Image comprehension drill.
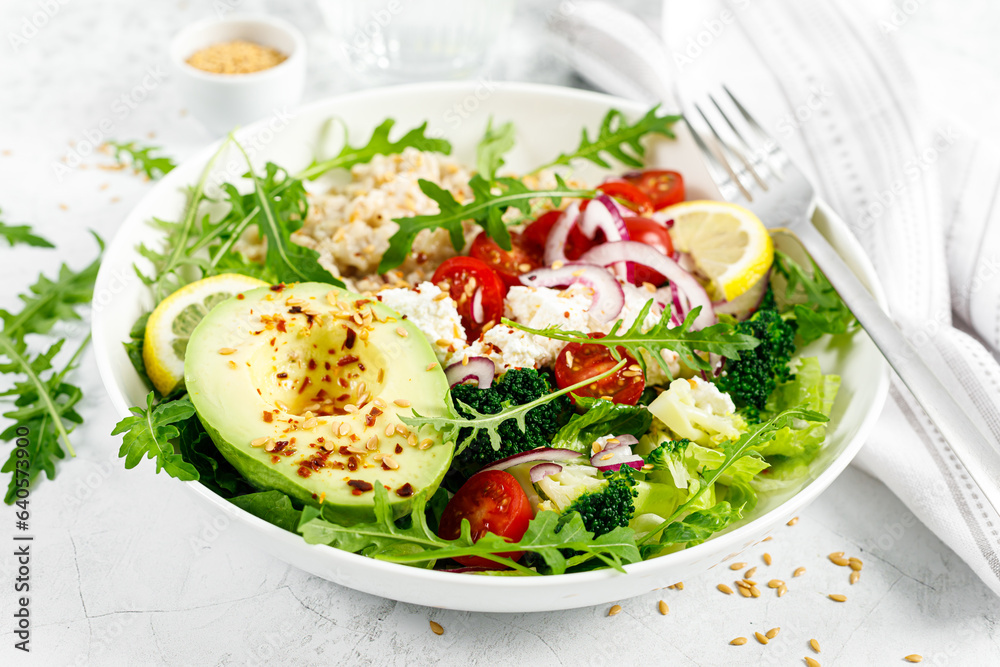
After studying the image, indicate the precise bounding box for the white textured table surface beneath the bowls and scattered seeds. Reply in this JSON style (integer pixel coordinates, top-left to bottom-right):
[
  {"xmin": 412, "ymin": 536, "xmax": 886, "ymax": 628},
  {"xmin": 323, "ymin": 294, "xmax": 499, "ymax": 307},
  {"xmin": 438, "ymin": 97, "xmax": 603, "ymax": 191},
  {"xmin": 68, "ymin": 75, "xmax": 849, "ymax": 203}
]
[{"xmin": 0, "ymin": 0, "xmax": 1000, "ymax": 665}]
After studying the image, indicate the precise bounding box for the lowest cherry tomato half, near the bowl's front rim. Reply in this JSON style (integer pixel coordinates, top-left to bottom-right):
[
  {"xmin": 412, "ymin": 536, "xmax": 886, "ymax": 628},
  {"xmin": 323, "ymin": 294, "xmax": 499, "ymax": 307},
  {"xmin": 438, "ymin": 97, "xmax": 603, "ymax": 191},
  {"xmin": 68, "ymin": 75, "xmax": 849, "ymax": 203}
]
[{"xmin": 438, "ymin": 470, "xmax": 531, "ymax": 568}]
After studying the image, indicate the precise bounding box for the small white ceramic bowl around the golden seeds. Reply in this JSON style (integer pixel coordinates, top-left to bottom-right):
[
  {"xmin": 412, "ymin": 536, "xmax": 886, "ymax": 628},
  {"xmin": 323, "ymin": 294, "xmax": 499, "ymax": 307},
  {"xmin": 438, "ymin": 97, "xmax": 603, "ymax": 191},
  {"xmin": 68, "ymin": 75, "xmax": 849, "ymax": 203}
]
[{"xmin": 170, "ymin": 16, "xmax": 306, "ymax": 135}]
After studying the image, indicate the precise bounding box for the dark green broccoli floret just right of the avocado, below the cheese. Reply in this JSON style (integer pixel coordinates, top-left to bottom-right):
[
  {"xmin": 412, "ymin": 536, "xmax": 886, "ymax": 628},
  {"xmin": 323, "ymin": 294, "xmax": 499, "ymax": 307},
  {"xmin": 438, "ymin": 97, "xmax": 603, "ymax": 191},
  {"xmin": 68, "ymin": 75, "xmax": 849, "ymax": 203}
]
[{"xmin": 451, "ymin": 368, "xmax": 571, "ymax": 476}]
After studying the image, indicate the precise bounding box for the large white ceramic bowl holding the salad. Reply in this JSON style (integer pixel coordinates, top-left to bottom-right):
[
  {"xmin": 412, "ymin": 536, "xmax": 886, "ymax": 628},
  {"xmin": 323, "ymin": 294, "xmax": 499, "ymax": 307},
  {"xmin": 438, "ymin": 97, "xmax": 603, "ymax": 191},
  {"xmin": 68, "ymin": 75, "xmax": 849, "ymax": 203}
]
[{"xmin": 93, "ymin": 83, "xmax": 888, "ymax": 612}]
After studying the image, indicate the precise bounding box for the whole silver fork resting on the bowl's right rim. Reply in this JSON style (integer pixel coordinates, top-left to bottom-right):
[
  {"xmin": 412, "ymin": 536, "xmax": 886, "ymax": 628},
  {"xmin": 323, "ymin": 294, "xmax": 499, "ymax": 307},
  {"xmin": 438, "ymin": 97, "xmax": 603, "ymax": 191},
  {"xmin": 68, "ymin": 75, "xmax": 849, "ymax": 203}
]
[{"xmin": 684, "ymin": 86, "xmax": 1000, "ymax": 512}]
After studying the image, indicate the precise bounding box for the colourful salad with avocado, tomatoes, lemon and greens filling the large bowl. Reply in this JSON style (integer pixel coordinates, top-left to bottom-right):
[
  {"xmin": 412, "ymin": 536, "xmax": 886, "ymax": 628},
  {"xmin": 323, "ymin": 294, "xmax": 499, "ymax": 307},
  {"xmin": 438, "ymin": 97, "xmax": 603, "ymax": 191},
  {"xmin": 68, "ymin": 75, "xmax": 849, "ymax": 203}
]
[{"xmin": 114, "ymin": 92, "xmax": 854, "ymax": 577}]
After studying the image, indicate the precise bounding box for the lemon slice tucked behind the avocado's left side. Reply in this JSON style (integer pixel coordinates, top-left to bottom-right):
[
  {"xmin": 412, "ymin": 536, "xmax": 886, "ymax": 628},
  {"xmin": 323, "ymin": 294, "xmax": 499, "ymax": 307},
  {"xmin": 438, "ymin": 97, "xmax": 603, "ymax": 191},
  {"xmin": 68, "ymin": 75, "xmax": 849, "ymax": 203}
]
[{"xmin": 142, "ymin": 273, "xmax": 267, "ymax": 394}]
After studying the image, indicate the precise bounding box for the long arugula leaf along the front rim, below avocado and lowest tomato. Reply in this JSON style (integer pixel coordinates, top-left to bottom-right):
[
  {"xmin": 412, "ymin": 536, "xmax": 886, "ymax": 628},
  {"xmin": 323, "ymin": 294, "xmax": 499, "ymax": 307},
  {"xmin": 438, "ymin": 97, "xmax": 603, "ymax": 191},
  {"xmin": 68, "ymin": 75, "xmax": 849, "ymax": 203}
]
[{"xmin": 299, "ymin": 485, "xmax": 639, "ymax": 575}]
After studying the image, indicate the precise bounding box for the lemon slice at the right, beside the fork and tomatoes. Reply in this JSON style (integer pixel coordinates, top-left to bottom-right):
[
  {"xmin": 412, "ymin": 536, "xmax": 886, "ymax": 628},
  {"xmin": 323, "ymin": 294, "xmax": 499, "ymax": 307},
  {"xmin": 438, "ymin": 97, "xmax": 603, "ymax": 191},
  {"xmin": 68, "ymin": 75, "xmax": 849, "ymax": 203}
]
[{"xmin": 661, "ymin": 201, "xmax": 774, "ymax": 301}]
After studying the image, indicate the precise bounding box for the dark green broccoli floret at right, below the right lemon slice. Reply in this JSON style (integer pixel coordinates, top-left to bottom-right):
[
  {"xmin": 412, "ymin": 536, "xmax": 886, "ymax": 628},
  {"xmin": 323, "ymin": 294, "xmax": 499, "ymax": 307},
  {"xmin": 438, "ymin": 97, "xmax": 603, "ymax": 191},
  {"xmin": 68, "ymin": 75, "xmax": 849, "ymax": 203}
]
[{"xmin": 717, "ymin": 288, "xmax": 796, "ymax": 420}]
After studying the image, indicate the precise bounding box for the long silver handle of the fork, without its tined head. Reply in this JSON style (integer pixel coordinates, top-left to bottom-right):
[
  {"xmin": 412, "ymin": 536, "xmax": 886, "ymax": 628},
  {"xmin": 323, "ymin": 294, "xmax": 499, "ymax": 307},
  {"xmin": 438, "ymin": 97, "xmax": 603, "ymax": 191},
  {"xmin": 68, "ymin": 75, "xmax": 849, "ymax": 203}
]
[{"xmin": 792, "ymin": 220, "xmax": 1000, "ymax": 513}]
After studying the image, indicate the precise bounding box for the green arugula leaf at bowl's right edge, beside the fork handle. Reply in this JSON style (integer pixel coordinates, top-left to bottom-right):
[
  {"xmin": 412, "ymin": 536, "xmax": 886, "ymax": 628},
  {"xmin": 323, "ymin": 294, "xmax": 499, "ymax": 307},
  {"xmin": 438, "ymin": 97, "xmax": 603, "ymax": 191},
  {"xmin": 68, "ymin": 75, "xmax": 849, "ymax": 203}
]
[{"xmin": 774, "ymin": 250, "xmax": 857, "ymax": 343}]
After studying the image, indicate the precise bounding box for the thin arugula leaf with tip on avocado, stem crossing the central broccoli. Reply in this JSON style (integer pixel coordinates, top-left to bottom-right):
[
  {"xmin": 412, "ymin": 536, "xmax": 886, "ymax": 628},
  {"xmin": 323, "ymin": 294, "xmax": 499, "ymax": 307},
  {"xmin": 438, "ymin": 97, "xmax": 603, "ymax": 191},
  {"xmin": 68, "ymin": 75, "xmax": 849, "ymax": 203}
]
[{"xmin": 399, "ymin": 359, "xmax": 628, "ymax": 456}]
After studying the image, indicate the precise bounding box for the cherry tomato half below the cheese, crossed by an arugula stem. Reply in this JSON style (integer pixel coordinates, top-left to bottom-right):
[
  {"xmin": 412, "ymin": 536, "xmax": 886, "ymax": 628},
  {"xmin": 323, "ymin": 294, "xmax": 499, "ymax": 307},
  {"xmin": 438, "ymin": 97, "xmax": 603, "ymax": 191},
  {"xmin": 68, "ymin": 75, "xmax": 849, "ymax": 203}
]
[{"xmin": 555, "ymin": 333, "xmax": 646, "ymax": 405}]
